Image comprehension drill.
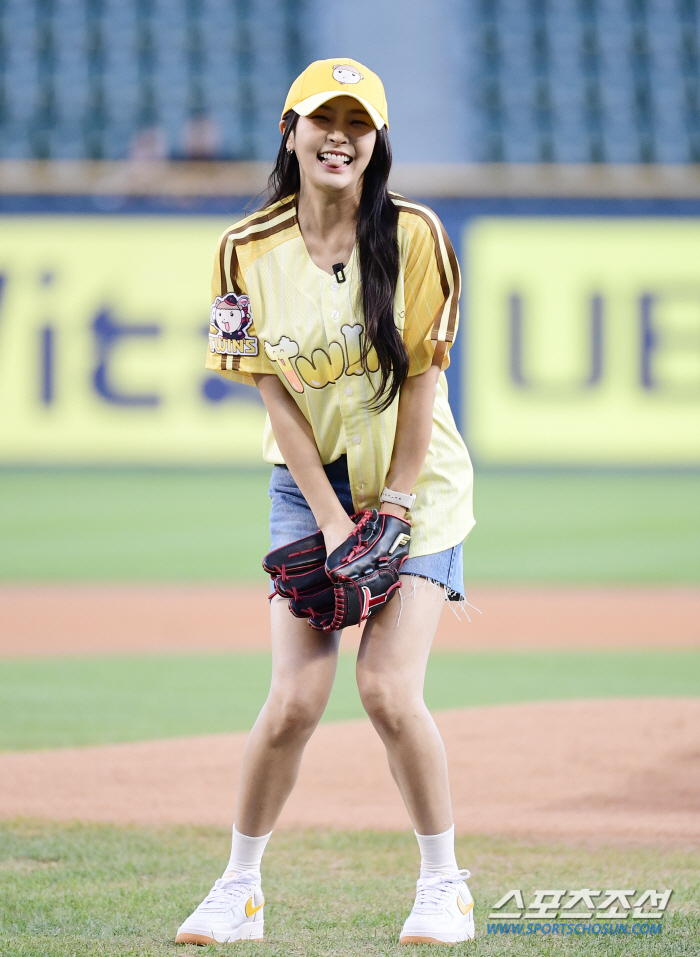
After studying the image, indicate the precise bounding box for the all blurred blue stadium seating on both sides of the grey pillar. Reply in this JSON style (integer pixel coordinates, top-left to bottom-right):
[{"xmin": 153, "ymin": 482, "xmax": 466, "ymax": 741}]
[{"xmin": 0, "ymin": 0, "xmax": 700, "ymax": 163}]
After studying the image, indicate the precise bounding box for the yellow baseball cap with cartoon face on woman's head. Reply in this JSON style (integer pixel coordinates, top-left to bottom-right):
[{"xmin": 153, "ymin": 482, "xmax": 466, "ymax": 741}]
[{"xmin": 282, "ymin": 57, "xmax": 389, "ymax": 130}]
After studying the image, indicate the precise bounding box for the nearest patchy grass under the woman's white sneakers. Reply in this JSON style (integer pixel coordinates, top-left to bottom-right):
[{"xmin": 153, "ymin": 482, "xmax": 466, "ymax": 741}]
[{"xmin": 0, "ymin": 821, "xmax": 700, "ymax": 957}]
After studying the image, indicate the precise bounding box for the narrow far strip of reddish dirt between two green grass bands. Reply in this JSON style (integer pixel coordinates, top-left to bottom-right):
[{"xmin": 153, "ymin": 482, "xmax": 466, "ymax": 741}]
[{"xmin": 0, "ymin": 585, "xmax": 700, "ymax": 655}]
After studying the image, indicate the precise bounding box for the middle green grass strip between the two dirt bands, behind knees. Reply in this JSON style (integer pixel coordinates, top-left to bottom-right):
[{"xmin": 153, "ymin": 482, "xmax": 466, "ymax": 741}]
[{"xmin": 0, "ymin": 651, "xmax": 700, "ymax": 750}]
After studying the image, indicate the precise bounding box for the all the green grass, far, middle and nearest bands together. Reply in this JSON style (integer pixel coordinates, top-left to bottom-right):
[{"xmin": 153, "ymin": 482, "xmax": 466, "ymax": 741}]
[{"xmin": 0, "ymin": 470, "xmax": 700, "ymax": 957}]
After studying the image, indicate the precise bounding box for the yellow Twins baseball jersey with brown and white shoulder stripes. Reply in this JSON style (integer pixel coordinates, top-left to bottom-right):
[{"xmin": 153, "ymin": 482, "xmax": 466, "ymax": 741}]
[{"xmin": 207, "ymin": 194, "xmax": 474, "ymax": 557}]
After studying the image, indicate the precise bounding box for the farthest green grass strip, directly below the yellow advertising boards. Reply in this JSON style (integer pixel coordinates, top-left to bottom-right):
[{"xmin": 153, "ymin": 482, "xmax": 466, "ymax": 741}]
[{"xmin": 0, "ymin": 470, "xmax": 700, "ymax": 584}]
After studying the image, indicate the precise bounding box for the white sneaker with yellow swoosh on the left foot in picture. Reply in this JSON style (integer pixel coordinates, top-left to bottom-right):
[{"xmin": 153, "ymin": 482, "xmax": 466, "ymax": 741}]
[{"xmin": 175, "ymin": 871, "xmax": 265, "ymax": 944}]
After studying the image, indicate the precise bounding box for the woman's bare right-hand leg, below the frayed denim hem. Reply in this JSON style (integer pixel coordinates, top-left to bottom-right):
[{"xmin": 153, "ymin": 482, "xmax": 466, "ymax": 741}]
[{"xmin": 357, "ymin": 575, "xmax": 452, "ymax": 834}]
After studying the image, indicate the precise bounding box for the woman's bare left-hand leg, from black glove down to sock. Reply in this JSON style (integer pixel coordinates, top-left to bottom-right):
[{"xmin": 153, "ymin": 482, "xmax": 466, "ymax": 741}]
[{"xmin": 236, "ymin": 598, "xmax": 341, "ymax": 837}]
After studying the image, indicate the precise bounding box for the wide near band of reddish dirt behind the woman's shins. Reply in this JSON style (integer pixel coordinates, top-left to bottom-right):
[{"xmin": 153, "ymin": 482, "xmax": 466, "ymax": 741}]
[{"xmin": 0, "ymin": 699, "xmax": 700, "ymax": 846}]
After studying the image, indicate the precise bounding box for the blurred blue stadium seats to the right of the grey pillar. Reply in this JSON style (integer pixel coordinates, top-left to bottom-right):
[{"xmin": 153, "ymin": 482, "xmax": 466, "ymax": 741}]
[{"xmin": 474, "ymin": 0, "xmax": 700, "ymax": 163}]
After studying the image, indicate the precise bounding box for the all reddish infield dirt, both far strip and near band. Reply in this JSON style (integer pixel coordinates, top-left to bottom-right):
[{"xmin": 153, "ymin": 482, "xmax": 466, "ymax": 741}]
[{"xmin": 0, "ymin": 586, "xmax": 700, "ymax": 846}]
